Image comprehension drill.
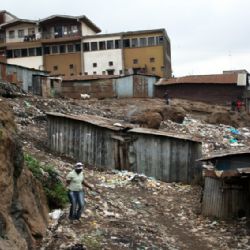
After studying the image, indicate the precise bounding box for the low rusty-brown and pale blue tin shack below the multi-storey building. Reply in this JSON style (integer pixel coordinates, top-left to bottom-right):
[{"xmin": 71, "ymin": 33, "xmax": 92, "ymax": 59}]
[{"xmin": 61, "ymin": 74, "xmax": 158, "ymax": 99}]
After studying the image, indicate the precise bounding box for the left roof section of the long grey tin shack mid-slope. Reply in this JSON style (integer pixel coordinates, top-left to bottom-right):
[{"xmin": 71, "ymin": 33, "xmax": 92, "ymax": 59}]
[{"xmin": 46, "ymin": 112, "xmax": 134, "ymax": 131}]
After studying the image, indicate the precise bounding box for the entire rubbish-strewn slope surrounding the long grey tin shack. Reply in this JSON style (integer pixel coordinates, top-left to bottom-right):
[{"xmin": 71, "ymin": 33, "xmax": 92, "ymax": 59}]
[{"xmin": 1, "ymin": 93, "xmax": 250, "ymax": 250}]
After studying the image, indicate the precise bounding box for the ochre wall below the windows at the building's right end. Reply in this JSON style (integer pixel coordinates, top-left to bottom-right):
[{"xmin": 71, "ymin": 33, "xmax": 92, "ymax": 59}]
[{"xmin": 124, "ymin": 45, "xmax": 164, "ymax": 77}]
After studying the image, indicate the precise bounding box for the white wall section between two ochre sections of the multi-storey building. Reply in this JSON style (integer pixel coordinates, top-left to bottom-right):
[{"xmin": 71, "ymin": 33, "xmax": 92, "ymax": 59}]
[{"xmin": 83, "ymin": 36, "xmax": 124, "ymax": 75}]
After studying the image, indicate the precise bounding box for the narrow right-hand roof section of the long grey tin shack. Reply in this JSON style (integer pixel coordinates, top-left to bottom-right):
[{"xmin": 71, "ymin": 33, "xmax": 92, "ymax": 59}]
[{"xmin": 128, "ymin": 128, "xmax": 201, "ymax": 143}]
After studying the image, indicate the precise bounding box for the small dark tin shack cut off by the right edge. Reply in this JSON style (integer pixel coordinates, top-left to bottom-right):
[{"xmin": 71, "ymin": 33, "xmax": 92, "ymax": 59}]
[{"xmin": 200, "ymin": 152, "xmax": 250, "ymax": 219}]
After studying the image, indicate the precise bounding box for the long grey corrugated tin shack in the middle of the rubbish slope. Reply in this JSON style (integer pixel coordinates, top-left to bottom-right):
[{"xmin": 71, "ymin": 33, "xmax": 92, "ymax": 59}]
[{"xmin": 47, "ymin": 113, "xmax": 201, "ymax": 183}]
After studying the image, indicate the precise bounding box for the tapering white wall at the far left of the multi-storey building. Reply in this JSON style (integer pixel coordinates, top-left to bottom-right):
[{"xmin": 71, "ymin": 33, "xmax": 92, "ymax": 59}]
[{"xmin": 7, "ymin": 56, "xmax": 43, "ymax": 70}]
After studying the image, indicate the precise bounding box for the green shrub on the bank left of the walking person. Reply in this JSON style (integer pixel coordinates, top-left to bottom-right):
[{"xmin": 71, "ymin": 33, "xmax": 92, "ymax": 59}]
[{"xmin": 24, "ymin": 154, "xmax": 68, "ymax": 209}]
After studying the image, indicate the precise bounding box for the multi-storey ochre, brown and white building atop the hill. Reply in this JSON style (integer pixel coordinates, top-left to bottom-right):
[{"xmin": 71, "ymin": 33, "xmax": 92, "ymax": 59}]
[{"xmin": 0, "ymin": 12, "xmax": 171, "ymax": 77}]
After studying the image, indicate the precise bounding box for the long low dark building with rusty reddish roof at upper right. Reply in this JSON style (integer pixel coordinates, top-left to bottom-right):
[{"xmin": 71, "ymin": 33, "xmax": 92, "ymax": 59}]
[{"xmin": 155, "ymin": 71, "xmax": 246, "ymax": 105}]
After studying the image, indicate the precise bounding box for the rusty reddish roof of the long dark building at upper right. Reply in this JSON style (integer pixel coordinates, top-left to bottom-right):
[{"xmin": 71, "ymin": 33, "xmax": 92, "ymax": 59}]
[{"xmin": 155, "ymin": 74, "xmax": 238, "ymax": 86}]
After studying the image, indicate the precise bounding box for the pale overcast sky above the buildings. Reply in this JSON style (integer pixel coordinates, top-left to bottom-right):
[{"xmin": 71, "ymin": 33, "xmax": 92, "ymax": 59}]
[{"xmin": 0, "ymin": 0, "xmax": 250, "ymax": 76}]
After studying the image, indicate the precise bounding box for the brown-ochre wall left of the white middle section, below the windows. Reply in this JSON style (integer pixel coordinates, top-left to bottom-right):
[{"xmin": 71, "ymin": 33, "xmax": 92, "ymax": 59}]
[{"xmin": 44, "ymin": 53, "xmax": 82, "ymax": 76}]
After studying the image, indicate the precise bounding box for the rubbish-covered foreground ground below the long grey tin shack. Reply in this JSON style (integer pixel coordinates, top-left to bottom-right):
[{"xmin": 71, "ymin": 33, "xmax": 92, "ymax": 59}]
[{"xmin": 40, "ymin": 169, "xmax": 250, "ymax": 250}]
